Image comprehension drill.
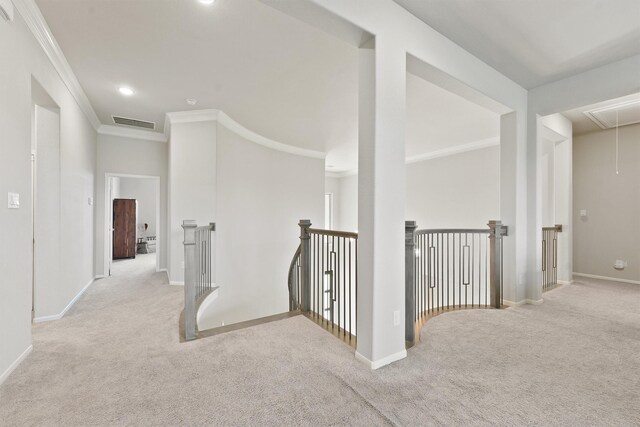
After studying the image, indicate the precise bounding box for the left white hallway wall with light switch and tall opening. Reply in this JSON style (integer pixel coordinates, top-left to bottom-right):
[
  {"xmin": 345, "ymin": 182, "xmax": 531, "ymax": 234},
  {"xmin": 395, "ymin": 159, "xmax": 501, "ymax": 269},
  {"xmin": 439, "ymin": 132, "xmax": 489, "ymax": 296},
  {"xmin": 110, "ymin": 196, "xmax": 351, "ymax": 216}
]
[{"xmin": 0, "ymin": 13, "xmax": 96, "ymax": 381}]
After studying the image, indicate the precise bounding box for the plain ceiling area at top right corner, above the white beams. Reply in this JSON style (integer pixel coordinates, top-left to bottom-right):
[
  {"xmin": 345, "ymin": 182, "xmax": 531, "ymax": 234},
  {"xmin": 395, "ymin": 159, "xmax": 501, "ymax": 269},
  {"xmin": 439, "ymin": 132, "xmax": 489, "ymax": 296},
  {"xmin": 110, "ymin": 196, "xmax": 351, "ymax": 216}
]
[{"xmin": 395, "ymin": 0, "xmax": 640, "ymax": 89}]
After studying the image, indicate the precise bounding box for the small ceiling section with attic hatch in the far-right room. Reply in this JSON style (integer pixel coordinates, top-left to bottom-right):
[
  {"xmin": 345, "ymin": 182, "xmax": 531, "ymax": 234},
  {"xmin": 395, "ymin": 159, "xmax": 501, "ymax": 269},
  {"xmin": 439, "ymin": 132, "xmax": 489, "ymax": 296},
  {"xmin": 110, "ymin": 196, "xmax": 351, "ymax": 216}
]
[{"xmin": 562, "ymin": 93, "xmax": 640, "ymax": 135}]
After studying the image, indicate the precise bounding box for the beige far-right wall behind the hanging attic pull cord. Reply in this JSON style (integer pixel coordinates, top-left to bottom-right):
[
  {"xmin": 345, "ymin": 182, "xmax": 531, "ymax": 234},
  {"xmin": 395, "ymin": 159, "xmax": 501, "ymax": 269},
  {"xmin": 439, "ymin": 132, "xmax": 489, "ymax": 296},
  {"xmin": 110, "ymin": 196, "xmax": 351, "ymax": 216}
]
[{"xmin": 573, "ymin": 125, "xmax": 640, "ymax": 282}]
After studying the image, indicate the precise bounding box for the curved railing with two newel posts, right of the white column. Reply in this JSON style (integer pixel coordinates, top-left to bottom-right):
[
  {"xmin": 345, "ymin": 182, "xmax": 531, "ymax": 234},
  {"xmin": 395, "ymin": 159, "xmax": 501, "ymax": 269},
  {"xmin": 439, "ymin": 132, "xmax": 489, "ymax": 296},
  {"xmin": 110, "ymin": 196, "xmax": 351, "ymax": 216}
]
[{"xmin": 405, "ymin": 221, "xmax": 508, "ymax": 347}]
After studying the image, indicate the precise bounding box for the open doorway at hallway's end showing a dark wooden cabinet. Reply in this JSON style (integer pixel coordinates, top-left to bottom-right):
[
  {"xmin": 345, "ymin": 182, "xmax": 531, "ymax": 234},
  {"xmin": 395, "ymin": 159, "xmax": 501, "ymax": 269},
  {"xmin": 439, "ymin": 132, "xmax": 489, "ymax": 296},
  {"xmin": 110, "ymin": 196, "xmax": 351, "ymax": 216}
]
[{"xmin": 104, "ymin": 173, "xmax": 161, "ymax": 276}]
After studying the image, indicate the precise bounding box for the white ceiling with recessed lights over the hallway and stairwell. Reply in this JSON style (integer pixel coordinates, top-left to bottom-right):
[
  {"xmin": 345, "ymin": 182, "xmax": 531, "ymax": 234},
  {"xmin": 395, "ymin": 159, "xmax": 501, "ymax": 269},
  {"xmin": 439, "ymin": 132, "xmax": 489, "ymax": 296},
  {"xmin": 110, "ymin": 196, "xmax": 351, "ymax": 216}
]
[{"xmin": 36, "ymin": 0, "xmax": 499, "ymax": 171}]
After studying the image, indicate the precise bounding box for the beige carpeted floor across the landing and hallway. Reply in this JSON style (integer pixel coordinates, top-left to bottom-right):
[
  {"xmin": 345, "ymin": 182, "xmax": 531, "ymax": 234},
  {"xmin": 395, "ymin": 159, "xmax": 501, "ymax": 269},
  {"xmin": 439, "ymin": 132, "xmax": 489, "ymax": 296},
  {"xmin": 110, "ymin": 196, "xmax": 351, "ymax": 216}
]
[{"xmin": 0, "ymin": 264, "xmax": 640, "ymax": 426}]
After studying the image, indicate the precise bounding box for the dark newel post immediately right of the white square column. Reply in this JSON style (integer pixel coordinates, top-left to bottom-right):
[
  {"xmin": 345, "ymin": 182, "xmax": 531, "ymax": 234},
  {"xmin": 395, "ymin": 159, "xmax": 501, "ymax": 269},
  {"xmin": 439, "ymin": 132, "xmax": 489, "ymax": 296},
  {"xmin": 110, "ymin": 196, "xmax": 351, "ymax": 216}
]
[{"xmin": 404, "ymin": 221, "xmax": 418, "ymax": 347}]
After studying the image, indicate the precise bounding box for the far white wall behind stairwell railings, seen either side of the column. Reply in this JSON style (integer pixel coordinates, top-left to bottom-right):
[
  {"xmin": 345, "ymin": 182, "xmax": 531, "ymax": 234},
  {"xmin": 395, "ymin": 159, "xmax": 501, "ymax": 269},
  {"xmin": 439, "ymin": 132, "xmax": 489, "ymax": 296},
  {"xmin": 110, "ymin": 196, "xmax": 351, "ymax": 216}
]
[{"xmin": 336, "ymin": 146, "xmax": 500, "ymax": 231}]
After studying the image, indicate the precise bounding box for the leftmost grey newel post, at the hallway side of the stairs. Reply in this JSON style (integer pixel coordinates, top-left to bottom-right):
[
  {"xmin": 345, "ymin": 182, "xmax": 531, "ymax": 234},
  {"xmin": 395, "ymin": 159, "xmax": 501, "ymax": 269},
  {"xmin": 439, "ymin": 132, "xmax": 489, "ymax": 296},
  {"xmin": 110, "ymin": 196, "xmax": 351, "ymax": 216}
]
[{"xmin": 182, "ymin": 220, "xmax": 197, "ymax": 341}]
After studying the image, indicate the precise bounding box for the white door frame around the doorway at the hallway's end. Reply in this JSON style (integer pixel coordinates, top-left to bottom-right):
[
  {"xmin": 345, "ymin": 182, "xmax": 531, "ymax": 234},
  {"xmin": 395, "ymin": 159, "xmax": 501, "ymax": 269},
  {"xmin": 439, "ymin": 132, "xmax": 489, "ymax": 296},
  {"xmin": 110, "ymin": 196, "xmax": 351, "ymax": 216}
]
[{"xmin": 103, "ymin": 172, "xmax": 163, "ymax": 277}]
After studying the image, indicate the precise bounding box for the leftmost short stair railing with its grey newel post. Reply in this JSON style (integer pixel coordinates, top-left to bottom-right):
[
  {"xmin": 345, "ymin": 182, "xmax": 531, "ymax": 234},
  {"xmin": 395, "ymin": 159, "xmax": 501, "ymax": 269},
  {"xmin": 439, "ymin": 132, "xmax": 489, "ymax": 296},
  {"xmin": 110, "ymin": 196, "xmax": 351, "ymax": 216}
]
[{"xmin": 182, "ymin": 220, "xmax": 216, "ymax": 341}]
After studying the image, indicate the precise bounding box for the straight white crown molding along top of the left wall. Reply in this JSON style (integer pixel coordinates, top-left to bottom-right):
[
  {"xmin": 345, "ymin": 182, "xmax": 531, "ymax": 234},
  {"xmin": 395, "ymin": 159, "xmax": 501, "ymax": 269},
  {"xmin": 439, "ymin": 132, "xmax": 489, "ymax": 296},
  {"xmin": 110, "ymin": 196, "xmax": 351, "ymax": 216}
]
[{"xmin": 13, "ymin": 0, "xmax": 101, "ymax": 131}]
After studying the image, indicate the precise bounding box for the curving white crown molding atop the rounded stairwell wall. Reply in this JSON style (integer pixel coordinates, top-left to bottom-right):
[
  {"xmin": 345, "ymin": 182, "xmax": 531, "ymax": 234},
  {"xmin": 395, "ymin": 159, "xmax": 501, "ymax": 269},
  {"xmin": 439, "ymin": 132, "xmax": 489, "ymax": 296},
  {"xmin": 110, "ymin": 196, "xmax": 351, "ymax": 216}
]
[{"xmin": 164, "ymin": 109, "xmax": 326, "ymax": 160}]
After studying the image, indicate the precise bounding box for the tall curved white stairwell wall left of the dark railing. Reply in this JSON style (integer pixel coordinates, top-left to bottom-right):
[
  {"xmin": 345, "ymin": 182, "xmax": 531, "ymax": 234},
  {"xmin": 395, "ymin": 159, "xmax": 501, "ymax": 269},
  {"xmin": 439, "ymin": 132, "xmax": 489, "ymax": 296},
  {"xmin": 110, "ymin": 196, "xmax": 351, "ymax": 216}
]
[{"xmin": 200, "ymin": 125, "xmax": 324, "ymax": 328}]
